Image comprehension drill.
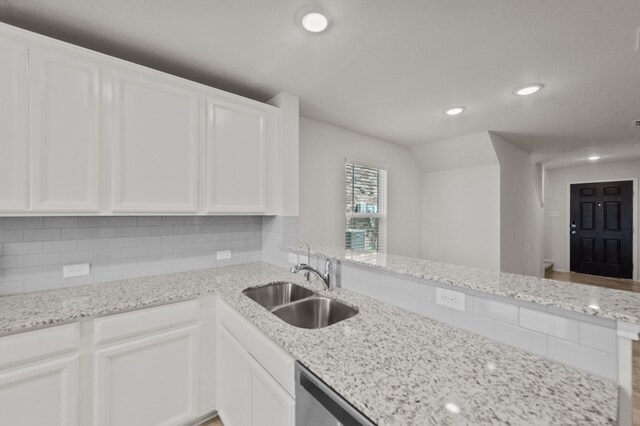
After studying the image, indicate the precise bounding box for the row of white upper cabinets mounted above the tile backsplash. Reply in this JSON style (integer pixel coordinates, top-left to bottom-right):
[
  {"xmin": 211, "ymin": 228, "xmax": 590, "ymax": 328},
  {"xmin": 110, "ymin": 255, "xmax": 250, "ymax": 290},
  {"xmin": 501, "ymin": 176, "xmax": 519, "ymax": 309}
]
[{"xmin": 0, "ymin": 23, "xmax": 284, "ymax": 216}]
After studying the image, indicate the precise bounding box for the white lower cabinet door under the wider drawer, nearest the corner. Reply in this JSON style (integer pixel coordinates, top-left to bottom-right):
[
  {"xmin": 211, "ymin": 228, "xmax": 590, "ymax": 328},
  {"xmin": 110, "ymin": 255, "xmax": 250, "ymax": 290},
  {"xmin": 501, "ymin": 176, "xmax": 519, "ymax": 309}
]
[{"xmin": 95, "ymin": 326, "xmax": 199, "ymax": 426}]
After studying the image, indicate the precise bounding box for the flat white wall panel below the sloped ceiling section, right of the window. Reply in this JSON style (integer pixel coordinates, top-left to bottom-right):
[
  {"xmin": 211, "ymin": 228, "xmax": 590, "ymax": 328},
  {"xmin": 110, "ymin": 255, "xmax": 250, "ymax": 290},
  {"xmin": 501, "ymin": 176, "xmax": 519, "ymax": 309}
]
[{"xmin": 422, "ymin": 165, "xmax": 500, "ymax": 270}]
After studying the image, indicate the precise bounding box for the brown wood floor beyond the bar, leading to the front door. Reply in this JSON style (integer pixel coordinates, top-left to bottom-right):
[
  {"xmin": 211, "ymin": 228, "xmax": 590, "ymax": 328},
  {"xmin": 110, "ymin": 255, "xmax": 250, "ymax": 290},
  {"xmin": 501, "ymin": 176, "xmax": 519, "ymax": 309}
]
[{"xmin": 545, "ymin": 270, "xmax": 640, "ymax": 425}]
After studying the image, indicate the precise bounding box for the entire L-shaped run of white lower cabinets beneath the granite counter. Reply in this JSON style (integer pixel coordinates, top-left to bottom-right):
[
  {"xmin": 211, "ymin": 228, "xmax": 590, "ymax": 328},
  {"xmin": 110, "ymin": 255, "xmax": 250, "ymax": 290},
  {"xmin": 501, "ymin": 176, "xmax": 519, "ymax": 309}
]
[{"xmin": 0, "ymin": 296, "xmax": 295, "ymax": 426}]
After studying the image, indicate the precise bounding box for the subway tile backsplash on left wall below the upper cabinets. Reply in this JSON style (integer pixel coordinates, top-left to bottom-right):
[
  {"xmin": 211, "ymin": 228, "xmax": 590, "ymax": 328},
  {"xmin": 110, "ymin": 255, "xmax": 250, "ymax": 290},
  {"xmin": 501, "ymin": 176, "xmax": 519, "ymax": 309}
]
[{"xmin": 0, "ymin": 216, "xmax": 262, "ymax": 294}]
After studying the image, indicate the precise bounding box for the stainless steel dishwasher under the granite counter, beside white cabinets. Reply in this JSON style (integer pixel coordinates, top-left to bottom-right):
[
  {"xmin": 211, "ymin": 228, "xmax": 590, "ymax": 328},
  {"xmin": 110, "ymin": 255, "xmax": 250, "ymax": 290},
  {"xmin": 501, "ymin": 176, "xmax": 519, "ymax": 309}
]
[{"xmin": 296, "ymin": 362, "xmax": 375, "ymax": 426}]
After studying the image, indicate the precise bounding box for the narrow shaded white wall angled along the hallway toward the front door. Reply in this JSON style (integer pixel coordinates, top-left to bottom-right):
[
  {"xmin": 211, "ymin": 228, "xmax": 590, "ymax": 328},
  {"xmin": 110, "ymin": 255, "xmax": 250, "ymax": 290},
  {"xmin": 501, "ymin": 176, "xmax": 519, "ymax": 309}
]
[{"xmin": 490, "ymin": 133, "xmax": 544, "ymax": 276}]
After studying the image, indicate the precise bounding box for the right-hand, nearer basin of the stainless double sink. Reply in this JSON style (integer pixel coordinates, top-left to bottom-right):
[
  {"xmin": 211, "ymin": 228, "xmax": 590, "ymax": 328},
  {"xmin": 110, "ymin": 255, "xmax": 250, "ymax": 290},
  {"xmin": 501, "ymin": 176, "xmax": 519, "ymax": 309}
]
[{"xmin": 273, "ymin": 297, "xmax": 358, "ymax": 328}]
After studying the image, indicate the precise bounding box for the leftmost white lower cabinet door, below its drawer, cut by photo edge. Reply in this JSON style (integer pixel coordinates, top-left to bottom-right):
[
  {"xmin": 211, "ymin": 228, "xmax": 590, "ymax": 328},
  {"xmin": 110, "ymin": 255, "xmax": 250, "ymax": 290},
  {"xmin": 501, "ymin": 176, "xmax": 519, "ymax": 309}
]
[{"xmin": 0, "ymin": 355, "xmax": 80, "ymax": 426}]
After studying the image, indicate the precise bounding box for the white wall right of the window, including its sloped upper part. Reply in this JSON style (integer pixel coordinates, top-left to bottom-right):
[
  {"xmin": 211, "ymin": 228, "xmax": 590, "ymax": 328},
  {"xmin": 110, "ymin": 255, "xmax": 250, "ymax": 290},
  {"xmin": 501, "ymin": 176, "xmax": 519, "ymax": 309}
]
[{"xmin": 411, "ymin": 132, "xmax": 500, "ymax": 270}]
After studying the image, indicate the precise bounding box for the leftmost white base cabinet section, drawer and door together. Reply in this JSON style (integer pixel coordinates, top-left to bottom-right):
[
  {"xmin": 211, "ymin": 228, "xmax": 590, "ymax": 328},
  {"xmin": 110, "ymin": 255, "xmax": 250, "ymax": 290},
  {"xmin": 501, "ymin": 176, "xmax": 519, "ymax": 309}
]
[{"xmin": 0, "ymin": 324, "xmax": 80, "ymax": 426}]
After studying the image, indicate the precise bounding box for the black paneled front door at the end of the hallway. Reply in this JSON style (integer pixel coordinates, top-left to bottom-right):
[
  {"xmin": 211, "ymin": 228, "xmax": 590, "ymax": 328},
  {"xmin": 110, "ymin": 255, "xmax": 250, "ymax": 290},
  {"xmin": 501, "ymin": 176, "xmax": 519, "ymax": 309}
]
[{"xmin": 569, "ymin": 181, "xmax": 633, "ymax": 278}]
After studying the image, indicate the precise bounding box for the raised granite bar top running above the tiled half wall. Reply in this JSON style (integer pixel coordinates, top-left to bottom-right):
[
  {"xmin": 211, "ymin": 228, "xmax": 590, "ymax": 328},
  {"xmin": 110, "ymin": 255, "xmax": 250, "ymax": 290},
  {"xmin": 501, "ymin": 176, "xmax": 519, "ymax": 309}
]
[{"xmin": 284, "ymin": 246, "xmax": 640, "ymax": 325}]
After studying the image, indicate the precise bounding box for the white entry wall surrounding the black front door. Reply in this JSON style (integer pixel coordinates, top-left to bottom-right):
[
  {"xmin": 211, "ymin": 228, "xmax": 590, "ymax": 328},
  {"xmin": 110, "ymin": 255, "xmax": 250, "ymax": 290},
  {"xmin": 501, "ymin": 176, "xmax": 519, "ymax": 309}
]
[{"xmin": 544, "ymin": 161, "xmax": 640, "ymax": 271}]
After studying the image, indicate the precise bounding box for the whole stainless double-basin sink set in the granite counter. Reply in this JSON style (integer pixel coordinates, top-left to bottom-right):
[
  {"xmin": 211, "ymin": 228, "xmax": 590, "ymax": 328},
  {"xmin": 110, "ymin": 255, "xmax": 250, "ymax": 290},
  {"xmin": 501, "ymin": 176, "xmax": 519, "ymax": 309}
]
[{"xmin": 243, "ymin": 282, "xmax": 358, "ymax": 329}]
